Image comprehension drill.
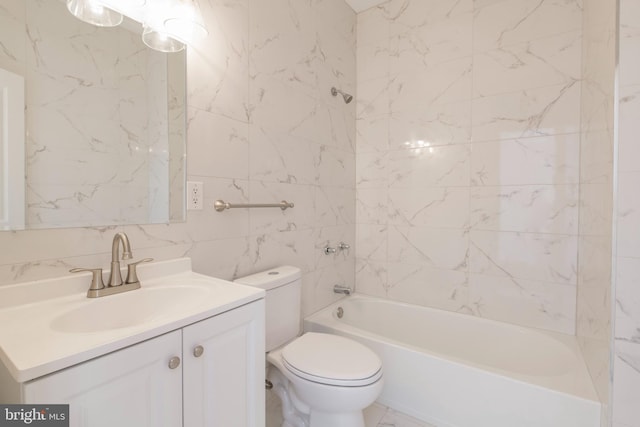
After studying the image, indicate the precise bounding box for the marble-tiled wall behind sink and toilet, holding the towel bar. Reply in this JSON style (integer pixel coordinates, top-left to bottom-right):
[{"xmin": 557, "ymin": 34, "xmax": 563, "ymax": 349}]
[{"xmin": 0, "ymin": 0, "xmax": 356, "ymax": 320}]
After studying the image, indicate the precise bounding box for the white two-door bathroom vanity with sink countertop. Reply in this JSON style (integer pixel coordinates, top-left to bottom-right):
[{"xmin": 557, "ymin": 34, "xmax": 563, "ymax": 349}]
[{"xmin": 0, "ymin": 259, "xmax": 265, "ymax": 427}]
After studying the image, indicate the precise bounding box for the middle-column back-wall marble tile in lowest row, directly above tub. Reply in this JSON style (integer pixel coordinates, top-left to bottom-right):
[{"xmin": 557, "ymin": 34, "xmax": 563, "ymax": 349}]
[{"xmin": 387, "ymin": 262, "xmax": 469, "ymax": 312}]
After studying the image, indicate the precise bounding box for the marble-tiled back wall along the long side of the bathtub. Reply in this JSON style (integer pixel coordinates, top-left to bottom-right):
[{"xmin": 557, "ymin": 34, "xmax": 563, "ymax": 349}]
[{"xmin": 356, "ymin": 0, "xmax": 582, "ymax": 334}]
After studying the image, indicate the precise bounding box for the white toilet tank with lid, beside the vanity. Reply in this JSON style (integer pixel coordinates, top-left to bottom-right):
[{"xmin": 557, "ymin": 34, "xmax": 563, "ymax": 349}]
[{"xmin": 235, "ymin": 265, "xmax": 302, "ymax": 351}]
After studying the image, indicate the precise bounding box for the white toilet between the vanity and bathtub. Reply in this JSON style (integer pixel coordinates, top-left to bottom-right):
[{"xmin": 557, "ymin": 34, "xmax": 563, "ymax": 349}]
[{"xmin": 236, "ymin": 266, "xmax": 383, "ymax": 427}]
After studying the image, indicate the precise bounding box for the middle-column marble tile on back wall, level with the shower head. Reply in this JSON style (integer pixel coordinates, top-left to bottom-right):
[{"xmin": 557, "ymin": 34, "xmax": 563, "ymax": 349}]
[{"xmin": 389, "ymin": 56, "xmax": 472, "ymax": 115}]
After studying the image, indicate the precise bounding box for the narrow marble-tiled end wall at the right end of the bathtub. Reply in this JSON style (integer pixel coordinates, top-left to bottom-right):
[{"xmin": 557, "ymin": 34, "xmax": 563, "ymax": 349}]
[{"xmin": 576, "ymin": 0, "xmax": 617, "ymax": 426}]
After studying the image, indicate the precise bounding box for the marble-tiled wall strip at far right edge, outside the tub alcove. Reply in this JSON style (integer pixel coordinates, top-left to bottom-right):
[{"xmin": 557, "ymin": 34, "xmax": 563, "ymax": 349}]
[{"xmin": 612, "ymin": 0, "xmax": 640, "ymax": 427}]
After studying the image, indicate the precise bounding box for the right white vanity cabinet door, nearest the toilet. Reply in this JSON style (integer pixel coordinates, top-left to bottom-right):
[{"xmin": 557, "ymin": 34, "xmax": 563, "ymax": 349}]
[{"xmin": 183, "ymin": 300, "xmax": 265, "ymax": 427}]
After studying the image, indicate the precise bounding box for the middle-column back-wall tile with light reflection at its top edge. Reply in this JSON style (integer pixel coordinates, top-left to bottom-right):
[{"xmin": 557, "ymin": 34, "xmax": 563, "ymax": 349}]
[{"xmin": 388, "ymin": 144, "xmax": 471, "ymax": 188}]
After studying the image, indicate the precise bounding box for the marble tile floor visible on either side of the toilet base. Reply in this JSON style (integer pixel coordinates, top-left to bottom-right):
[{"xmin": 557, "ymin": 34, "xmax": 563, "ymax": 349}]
[{"xmin": 266, "ymin": 391, "xmax": 436, "ymax": 427}]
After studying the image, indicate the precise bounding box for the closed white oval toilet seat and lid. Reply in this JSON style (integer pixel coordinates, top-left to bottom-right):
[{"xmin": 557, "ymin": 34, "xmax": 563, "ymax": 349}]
[{"xmin": 282, "ymin": 332, "xmax": 382, "ymax": 387}]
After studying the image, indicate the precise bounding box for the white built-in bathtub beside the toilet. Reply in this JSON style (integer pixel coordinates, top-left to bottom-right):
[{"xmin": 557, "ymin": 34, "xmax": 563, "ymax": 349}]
[{"xmin": 304, "ymin": 295, "xmax": 600, "ymax": 427}]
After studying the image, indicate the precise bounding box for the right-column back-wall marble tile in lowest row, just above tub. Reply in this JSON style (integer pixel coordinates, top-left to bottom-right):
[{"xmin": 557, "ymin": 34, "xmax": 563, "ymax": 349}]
[{"xmin": 469, "ymin": 274, "xmax": 576, "ymax": 335}]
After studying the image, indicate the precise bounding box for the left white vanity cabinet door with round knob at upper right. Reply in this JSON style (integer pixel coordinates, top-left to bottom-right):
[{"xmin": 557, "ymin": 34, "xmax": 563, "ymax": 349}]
[{"xmin": 23, "ymin": 331, "xmax": 182, "ymax": 427}]
